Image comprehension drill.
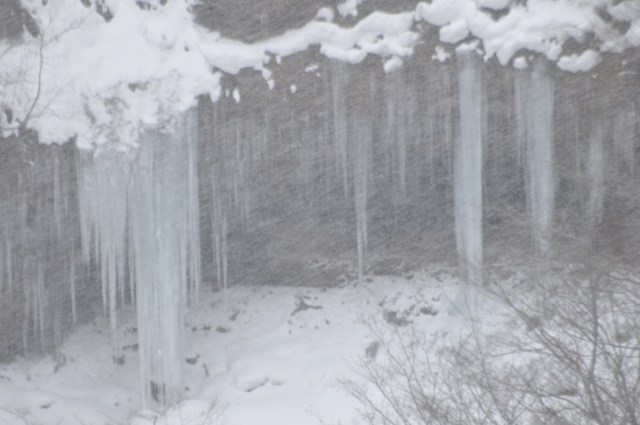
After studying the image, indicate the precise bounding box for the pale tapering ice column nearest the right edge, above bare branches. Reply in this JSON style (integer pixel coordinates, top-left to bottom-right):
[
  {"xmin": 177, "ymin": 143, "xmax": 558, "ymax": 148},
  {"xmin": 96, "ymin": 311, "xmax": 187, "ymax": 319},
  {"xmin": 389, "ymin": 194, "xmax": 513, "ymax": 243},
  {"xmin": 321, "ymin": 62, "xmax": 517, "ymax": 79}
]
[{"xmin": 525, "ymin": 58, "xmax": 555, "ymax": 254}]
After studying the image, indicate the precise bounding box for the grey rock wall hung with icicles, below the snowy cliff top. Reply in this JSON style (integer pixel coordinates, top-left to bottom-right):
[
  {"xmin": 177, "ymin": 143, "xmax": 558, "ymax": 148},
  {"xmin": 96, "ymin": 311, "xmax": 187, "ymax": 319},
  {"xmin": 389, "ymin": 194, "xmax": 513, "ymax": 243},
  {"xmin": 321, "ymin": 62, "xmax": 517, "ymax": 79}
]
[{"xmin": 0, "ymin": 40, "xmax": 640, "ymax": 414}]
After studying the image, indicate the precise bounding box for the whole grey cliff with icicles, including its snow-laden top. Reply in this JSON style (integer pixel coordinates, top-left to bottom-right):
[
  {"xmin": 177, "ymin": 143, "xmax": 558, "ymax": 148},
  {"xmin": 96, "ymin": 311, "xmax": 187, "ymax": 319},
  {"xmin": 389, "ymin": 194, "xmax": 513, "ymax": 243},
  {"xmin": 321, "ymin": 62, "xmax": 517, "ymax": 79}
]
[{"xmin": 0, "ymin": 0, "xmax": 640, "ymax": 410}]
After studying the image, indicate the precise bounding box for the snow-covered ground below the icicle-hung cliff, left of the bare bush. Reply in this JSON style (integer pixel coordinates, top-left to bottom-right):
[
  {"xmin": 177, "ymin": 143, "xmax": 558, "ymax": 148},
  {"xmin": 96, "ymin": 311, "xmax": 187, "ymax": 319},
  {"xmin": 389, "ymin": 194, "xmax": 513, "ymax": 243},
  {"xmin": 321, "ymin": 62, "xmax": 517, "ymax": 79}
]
[{"xmin": 0, "ymin": 267, "xmax": 465, "ymax": 425}]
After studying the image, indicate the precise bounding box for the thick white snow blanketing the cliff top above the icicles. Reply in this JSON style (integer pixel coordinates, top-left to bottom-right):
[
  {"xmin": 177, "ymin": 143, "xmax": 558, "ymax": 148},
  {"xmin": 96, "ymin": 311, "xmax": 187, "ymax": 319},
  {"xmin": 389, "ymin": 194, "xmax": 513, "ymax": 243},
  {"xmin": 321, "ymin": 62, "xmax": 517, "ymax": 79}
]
[{"xmin": 0, "ymin": 0, "xmax": 640, "ymax": 150}]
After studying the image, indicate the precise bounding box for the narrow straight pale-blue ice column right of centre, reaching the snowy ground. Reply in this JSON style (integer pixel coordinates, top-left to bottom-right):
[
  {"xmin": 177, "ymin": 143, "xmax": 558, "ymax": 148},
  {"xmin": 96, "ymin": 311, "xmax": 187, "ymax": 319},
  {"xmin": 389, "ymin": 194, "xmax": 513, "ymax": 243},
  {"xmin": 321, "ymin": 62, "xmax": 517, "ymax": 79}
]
[{"xmin": 454, "ymin": 50, "xmax": 482, "ymax": 283}]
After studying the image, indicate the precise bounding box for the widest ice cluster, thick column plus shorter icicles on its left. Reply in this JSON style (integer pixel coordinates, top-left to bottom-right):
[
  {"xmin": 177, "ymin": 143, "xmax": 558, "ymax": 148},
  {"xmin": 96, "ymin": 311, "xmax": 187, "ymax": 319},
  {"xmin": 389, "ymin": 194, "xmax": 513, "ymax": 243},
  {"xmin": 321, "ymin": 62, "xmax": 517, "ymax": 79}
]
[{"xmin": 78, "ymin": 107, "xmax": 200, "ymax": 406}]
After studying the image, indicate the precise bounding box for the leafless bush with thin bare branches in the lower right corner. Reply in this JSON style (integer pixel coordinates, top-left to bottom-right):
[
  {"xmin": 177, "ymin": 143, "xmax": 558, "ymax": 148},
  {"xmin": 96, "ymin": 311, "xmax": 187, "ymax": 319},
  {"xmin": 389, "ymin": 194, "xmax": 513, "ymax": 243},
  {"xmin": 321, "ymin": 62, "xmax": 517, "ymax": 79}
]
[{"xmin": 345, "ymin": 264, "xmax": 640, "ymax": 425}]
